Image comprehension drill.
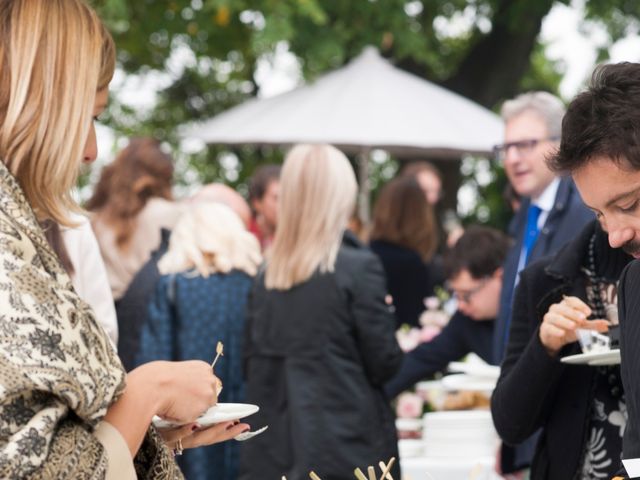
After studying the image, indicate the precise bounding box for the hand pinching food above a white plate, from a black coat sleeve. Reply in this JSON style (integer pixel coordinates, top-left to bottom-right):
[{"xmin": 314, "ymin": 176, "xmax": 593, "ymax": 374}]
[{"xmin": 540, "ymin": 297, "xmax": 609, "ymax": 356}]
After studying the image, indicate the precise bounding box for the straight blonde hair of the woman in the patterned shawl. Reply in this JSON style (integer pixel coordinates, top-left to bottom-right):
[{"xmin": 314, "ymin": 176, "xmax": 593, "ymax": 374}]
[{"xmin": 0, "ymin": 0, "xmax": 115, "ymax": 225}]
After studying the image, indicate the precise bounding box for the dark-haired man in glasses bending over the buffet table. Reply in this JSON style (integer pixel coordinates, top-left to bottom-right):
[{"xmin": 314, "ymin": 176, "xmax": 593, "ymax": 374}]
[{"xmin": 385, "ymin": 226, "xmax": 510, "ymax": 398}]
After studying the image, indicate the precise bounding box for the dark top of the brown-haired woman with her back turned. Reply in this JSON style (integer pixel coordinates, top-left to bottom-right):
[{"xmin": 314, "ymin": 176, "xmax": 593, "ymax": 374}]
[{"xmin": 370, "ymin": 240, "xmax": 445, "ymax": 327}]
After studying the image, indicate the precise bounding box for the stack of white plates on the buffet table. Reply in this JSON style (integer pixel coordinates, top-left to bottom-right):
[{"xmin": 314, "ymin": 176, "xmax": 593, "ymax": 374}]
[{"xmin": 422, "ymin": 410, "xmax": 498, "ymax": 458}]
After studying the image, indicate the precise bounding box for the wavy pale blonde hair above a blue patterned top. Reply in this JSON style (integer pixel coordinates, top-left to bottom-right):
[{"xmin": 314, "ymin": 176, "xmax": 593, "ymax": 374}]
[{"xmin": 158, "ymin": 202, "xmax": 262, "ymax": 277}]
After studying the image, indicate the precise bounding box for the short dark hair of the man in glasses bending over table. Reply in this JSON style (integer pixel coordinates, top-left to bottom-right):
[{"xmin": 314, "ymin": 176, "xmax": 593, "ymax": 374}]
[{"xmin": 444, "ymin": 225, "xmax": 511, "ymax": 279}]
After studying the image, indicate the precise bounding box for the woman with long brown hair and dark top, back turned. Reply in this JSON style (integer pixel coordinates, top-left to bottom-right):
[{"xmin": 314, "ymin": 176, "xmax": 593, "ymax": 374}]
[{"xmin": 369, "ymin": 176, "xmax": 444, "ymax": 327}]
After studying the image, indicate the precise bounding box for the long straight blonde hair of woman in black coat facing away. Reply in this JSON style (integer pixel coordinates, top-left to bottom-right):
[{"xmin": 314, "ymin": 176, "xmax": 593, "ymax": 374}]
[{"xmin": 265, "ymin": 145, "xmax": 357, "ymax": 290}]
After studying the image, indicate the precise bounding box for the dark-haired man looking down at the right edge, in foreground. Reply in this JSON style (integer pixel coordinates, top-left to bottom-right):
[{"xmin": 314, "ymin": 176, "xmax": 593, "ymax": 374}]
[{"xmin": 551, "ymin": 63, "xmax": 640, "ymax": 478}]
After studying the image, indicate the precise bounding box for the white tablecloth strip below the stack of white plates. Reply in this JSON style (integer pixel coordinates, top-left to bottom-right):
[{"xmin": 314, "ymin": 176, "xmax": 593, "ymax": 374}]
[{"xmin": 400, "ymin": 457, "xmax": 502, "ymax": 480}]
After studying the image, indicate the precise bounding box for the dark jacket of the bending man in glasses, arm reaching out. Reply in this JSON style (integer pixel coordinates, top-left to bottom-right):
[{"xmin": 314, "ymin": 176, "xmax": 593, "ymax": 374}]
[{"xmin": 384, "ymin": 311, "xmax": 493, "ymax": 398}]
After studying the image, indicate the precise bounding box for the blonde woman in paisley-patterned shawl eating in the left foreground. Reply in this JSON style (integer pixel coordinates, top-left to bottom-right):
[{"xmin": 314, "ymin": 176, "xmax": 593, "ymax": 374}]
[{"xmin": 0, "ymin": 0, "xmax": 242, "ymax": 480}]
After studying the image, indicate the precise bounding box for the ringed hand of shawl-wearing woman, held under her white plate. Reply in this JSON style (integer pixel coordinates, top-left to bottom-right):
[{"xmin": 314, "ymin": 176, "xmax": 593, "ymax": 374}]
[{"xmin": 159, "ymin": 420, "xmax": 251, "ymax": 449}]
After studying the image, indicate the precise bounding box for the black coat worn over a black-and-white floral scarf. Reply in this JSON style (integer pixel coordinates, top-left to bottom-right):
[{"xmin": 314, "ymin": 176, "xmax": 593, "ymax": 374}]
[{"xmin": 491, "ymin": 221, "xmax": 630, "ymax": 480}]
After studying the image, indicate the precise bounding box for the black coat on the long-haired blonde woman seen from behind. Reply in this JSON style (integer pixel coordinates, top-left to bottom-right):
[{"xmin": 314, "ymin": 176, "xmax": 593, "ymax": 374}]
[{"xmin": 239, "ymin": 245, "xmax": 402, "ymax": 480}]
